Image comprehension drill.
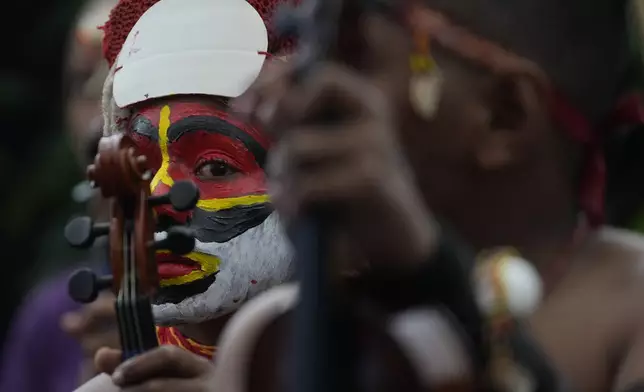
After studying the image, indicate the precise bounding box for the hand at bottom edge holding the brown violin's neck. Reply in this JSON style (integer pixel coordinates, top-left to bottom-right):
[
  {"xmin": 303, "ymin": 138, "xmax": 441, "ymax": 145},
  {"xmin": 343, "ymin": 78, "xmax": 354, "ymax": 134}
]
[{"xmin": 96, "ymin": 346, "xmax": 214, "ymax": 392}]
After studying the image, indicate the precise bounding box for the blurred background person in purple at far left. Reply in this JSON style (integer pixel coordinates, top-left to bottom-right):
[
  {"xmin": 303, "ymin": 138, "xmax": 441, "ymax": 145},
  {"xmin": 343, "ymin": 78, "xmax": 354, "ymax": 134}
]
[{"xmin": 0, "ymin": 0, "xmax": 116, "ymax": 392}]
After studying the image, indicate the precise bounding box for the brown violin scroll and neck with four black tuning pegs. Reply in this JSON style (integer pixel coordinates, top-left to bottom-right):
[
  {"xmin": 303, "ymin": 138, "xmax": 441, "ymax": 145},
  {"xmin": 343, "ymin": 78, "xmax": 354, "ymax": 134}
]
[{"xmin": 65, "ymin": 135, "xmax": 199, "ymax": 359}]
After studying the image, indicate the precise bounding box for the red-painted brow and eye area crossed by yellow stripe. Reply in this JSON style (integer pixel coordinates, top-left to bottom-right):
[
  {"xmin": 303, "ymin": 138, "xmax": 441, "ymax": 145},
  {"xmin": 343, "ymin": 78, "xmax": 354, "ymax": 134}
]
[{"xmin": 130, "ymin": 98, "xmax": 268, "ymax": 214}]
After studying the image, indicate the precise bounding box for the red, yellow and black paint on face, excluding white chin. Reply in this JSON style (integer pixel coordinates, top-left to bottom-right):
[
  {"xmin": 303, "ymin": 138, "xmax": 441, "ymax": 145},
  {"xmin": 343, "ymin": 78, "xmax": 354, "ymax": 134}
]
[{"xmin": 128, "ymin": 98, "xmax": 272, "ymax": 288}]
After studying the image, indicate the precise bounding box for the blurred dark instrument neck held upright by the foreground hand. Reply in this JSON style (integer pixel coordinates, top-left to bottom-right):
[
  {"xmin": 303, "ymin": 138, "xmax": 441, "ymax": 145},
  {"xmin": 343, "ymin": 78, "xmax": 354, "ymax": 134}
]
[{"xmin": 277, "ymin": 0, "xmax": 390, "ymax": 392}]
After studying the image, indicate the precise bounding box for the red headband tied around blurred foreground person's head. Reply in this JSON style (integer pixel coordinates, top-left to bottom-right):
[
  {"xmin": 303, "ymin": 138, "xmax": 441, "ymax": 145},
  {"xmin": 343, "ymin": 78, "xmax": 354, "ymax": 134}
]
[{"xmin": 408, "ymin": 4, "xmax": 644, "ymax": 226}]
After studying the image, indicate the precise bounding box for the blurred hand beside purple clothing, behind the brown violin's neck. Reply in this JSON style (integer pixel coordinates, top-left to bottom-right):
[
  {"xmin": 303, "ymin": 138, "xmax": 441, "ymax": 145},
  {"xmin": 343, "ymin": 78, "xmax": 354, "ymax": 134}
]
[{"xmin": 60, "ymin": 292, "xmax": 120, "ymax": 360}]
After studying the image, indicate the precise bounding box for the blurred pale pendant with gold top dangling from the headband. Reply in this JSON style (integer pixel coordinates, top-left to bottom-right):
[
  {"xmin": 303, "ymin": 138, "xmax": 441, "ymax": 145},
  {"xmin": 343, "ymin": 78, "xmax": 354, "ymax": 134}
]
[{"xmin": 409, "ymin": 34, "xmax": 443, "ymax": 119}]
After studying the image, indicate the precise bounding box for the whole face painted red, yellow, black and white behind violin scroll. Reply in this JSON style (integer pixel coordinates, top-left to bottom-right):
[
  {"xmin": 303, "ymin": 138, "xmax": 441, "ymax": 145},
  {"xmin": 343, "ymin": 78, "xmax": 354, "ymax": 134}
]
[{"xmin": 128, "ymin": 98, "xmax": 291, "ymax": 324}]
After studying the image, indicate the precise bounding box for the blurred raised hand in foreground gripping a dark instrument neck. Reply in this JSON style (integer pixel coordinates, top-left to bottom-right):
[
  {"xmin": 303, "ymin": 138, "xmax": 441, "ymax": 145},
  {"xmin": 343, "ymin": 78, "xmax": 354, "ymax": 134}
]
[{"xmin": 233, "ymin": 14, "xmax": 436, "ymax": 264}]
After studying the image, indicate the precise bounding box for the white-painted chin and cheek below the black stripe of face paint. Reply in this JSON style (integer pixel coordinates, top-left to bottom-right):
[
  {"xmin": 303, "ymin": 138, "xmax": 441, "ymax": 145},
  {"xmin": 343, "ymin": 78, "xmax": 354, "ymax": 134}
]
[{"xmin": 153, "ymin": 213, "xmax": 294, "ymax": 325}]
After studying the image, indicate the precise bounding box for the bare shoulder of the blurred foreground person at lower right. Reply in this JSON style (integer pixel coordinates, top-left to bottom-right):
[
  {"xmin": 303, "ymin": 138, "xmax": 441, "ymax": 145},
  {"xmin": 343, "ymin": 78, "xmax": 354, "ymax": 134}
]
[{"xmin": 530, "ymin": 229, "xmax": 644, "ymax": 392}]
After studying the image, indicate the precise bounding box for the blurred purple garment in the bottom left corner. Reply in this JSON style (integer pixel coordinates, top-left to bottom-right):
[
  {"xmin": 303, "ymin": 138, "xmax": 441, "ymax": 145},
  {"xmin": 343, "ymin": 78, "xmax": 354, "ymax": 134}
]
[{"xmin": 0, "ymin": 275, "xmax": 82, "ymax": 392}]
